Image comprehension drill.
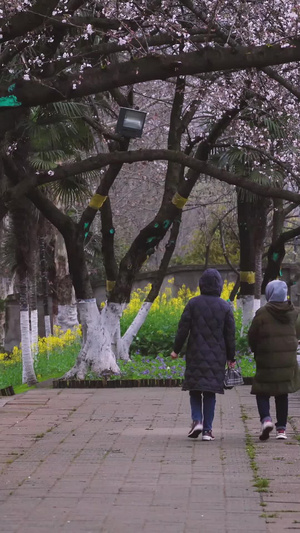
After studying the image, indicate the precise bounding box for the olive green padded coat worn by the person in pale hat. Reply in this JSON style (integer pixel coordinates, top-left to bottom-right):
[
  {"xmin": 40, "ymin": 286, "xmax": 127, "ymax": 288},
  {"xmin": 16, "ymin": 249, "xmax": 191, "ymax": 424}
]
[{"xmin": 248, "ymin": 301, "xmax": 300, "ymax": 396}]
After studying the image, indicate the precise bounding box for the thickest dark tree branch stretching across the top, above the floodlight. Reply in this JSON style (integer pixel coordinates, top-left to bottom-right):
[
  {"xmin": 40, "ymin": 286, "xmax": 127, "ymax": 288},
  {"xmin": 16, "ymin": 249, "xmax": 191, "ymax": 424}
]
[{"xmin": 6, "ymin": 42, "xmax": 300, "ymax": 111}]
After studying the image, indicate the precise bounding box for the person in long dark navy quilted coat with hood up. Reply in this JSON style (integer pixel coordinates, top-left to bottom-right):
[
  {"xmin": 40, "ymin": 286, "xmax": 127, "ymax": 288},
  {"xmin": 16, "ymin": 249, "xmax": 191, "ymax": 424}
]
[{"xmin": 171, "ymin": 268, "xmax": 235, "ymax": 441}]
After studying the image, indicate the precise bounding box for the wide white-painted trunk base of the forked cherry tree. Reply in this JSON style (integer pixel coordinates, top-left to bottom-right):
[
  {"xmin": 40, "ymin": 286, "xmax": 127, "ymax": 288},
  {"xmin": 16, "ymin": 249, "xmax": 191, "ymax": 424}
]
[{"xmin": 64, "ymin": 299, "xmax": 123, "ymax": 379}]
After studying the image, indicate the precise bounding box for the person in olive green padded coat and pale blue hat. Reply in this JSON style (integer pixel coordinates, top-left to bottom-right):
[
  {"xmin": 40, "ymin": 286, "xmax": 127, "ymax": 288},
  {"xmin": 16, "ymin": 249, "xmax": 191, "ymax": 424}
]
[{"xmin": 248, "ymin": 280, "xmax": 300, "ymax": 440}]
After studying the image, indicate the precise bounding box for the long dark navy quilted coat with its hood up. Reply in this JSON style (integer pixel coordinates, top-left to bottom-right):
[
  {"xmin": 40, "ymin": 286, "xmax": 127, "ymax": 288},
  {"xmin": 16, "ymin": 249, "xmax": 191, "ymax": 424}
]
[{"xmin": 174, "ymin": 268, "xmax": 235, "ymax": 394}]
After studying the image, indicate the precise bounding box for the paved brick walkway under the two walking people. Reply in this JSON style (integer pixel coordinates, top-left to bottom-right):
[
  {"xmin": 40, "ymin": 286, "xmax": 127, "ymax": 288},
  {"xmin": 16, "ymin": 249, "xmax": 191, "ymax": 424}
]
[{"xmin": 0, "ymin": 386, "xmax": 300, "ymax": 533}]
